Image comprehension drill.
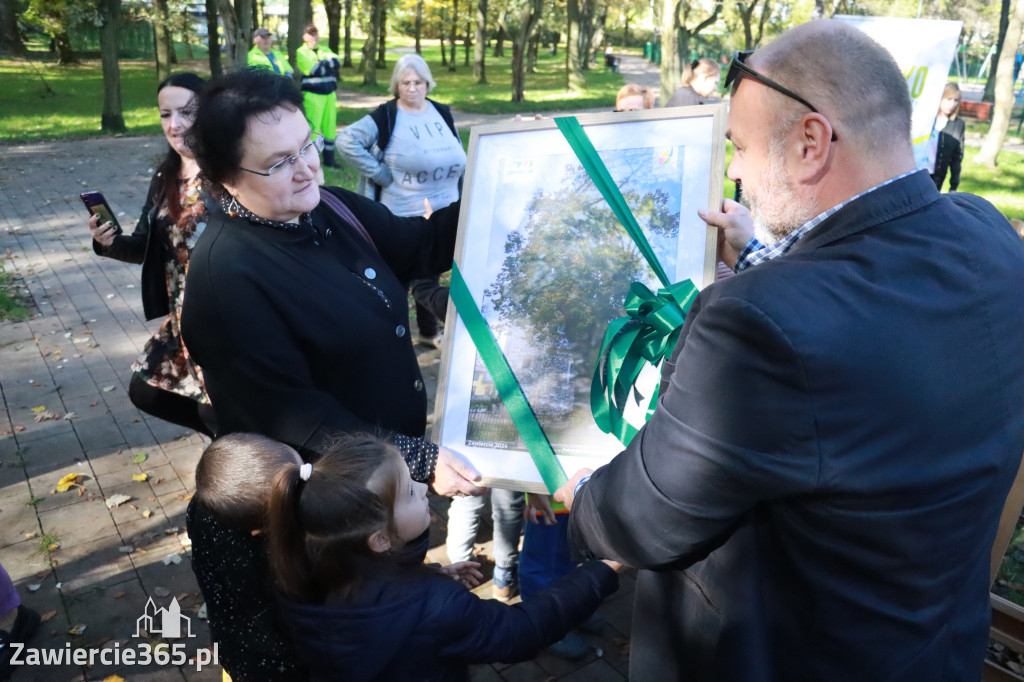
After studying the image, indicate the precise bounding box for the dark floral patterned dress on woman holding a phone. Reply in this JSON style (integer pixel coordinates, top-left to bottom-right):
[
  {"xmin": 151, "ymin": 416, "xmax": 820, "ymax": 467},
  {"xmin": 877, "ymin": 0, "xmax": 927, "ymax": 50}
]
[{"xmin": 131, "ymin": 176, "xmax": 210, "ymax": 403}]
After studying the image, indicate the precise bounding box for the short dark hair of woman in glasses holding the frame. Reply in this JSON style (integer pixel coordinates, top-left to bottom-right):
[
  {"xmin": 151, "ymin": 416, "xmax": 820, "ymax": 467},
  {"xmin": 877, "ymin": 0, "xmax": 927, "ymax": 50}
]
[{"xmin": 185, "ymin": 68, "xmax": 303, "ymax": 185}]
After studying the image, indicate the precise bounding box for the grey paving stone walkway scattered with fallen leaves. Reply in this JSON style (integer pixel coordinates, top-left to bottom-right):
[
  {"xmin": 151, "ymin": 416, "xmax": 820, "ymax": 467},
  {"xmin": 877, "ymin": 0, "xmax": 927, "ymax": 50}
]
[{"xmin": 0, "ymin": 93, "xmax": 632, "ymax": 682}]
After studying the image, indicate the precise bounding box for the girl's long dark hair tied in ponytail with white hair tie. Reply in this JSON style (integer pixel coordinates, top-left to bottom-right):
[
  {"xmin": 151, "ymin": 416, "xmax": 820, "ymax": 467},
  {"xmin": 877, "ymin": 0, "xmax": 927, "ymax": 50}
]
[{"xmin": 267, "ymin": 434, "xmax": 402, "ymax": 604}]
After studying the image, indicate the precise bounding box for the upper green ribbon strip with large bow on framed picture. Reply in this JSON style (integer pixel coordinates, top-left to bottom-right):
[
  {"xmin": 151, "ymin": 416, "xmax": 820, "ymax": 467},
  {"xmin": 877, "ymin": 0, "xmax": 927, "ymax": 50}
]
[{"xmin": 555, "ymin": 116, "xmax": 697, "ymax": 445}]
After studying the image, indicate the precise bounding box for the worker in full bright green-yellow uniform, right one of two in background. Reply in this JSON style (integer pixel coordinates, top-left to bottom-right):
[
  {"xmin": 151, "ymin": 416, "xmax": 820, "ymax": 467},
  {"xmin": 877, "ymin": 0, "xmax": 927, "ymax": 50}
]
[{"xmin": 295, "ymin": 24, "xmax": 341, "ymax": 167}]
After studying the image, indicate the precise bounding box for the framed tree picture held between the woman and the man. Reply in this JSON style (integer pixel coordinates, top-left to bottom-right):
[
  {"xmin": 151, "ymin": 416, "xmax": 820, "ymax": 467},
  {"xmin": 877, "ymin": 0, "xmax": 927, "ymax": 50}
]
[{"xmin": 433, "ymin": 104, "xmax": 725, "ymax": 493}]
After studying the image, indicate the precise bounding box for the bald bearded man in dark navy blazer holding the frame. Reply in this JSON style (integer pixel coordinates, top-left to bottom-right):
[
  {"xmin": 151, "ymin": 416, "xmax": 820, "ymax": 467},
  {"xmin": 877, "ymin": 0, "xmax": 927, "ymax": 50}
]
[{"xmin": 555, "ymin": 20, "xmax": 1024, "ymax": 682}]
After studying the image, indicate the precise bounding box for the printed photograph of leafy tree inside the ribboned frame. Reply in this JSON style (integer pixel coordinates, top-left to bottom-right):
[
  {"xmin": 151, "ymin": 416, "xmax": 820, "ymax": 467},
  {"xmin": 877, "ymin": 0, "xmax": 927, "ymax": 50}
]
[{"xmin": 466, "ymin": 146, "xmax": 685, "ymax": 455}]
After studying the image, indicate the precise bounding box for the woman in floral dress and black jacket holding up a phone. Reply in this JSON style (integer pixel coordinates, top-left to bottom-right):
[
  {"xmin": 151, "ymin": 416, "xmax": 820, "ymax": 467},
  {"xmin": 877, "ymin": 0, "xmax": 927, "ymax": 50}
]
[{"xmin": 89, "ymin": 73, "xmax": 216, "ymax": 437}]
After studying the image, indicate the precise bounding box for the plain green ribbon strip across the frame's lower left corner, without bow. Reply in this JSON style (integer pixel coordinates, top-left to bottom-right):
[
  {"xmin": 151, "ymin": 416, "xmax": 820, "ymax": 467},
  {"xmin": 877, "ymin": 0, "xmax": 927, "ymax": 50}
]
[{"xmin": 449, "ymin": 263, "xmax": 567, "ymax": 494}]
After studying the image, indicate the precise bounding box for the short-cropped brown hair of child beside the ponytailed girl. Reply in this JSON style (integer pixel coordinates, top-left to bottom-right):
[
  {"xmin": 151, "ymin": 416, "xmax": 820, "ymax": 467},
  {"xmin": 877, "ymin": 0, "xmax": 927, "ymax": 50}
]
[{"xmin": 196, "ymin": 433, "xmax": 297, "ymax": 530}]
